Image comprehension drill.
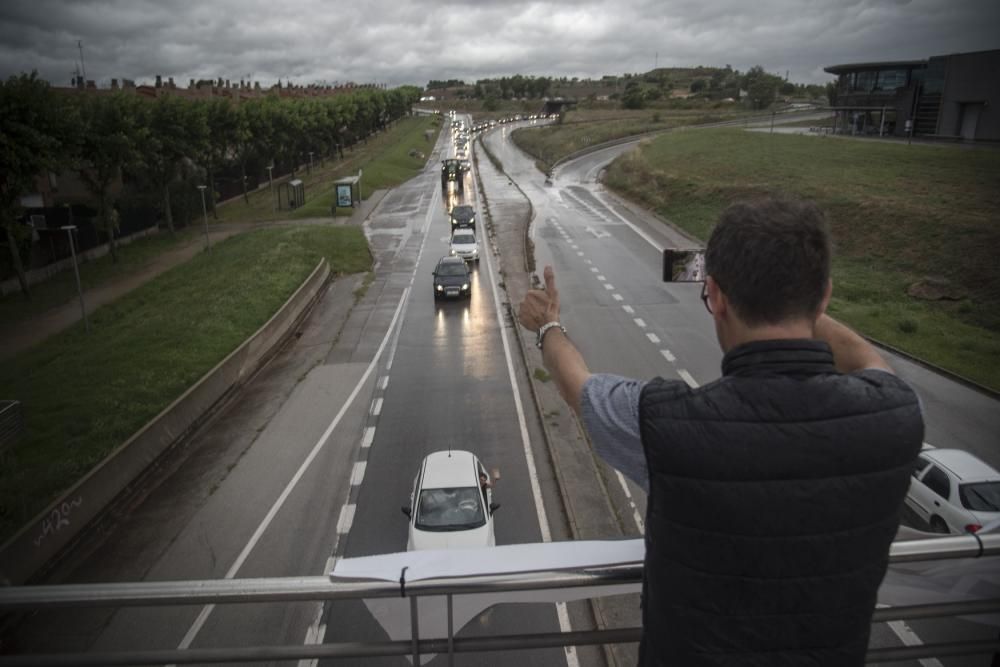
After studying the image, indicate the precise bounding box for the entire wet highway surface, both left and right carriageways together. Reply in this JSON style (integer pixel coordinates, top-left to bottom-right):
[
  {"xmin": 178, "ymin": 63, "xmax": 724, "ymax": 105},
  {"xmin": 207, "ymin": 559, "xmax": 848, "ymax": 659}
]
[{"xmin": 4, "ymin": 115, "xmax": 1000, "ymax": 667}]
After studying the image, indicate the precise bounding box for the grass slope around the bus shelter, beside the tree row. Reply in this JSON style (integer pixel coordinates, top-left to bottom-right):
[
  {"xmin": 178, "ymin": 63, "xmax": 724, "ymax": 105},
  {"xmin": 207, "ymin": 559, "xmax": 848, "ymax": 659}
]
[{"xmin": 219, "ymin": 116, "xmax": 441, "ymax": 222}]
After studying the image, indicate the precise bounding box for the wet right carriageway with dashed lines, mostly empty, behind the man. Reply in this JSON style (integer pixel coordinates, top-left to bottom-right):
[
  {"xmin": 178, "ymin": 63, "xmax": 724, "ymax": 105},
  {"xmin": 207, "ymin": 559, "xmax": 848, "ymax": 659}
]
[{"xmin": 486, "ymin": 121, "xmax": 1000, "ymax": 667}]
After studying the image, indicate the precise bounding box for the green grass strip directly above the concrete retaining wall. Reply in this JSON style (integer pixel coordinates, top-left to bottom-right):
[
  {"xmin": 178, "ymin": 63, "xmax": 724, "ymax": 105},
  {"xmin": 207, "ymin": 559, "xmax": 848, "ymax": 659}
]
[{"xmin": 0, "ymin": 226, "xmax": 371, "ymax": 540}]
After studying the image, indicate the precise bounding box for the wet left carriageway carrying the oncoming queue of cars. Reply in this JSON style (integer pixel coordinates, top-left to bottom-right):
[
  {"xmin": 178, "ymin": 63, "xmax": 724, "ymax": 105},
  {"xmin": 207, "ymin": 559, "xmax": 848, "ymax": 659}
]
[{"xmin": 5, "ymin": 120, "xmax": 601, "ymax": 667}]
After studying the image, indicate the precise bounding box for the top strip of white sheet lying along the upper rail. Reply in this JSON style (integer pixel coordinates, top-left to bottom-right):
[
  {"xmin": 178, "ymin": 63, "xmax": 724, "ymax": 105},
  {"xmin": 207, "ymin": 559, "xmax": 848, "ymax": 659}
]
[{"xmin": 330, "ymin": 538, "xmax": 646, "ymax": 581}]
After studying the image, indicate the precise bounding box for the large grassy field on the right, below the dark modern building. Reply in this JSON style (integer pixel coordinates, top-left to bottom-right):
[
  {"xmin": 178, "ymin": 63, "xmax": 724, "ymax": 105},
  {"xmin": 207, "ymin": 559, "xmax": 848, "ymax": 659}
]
[{"xmin": 606, "ymin": 130, "xmax": 1000, "ymax": 389}]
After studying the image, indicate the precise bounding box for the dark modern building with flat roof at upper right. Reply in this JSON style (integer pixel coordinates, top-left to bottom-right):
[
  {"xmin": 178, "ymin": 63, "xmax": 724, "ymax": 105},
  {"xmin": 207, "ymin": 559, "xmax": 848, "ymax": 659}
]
[{"xmin": 824, "ymin": 49, "xmax": 1000, "ymax": 141}]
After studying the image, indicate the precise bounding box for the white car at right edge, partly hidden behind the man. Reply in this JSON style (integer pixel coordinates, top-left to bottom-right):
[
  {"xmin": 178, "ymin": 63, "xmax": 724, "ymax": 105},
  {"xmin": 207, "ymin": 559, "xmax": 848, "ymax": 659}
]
[{"xmin": 906, "ymin": 448, "xmax": 1000, "ymax": 534}]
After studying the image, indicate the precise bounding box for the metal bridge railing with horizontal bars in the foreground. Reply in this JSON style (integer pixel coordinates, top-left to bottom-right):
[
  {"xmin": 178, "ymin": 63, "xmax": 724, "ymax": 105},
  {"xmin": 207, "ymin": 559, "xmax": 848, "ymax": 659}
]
[{"xmin": 0, "ymin": 534, "xmax": 1000, "ymax": 667}]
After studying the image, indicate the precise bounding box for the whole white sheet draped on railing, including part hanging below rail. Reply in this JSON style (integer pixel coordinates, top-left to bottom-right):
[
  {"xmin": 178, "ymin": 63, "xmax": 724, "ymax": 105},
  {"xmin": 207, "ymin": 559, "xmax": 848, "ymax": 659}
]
[{"xmin": 330, "ymin": 539, "xmax": 646, "ymax": 664}]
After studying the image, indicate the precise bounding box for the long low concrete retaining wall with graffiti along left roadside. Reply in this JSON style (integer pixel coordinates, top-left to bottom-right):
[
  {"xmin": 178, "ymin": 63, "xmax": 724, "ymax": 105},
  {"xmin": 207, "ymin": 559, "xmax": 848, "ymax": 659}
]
[{"xmin": 0, "ymin": 259, "xmax": 330, "ymax": 585}]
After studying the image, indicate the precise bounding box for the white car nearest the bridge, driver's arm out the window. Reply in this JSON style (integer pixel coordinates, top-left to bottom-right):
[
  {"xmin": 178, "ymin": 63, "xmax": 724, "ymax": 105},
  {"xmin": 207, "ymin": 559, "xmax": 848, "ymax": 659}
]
[{"xmin": 403, "ymin": 449, "xmax": 500, "ymax": 551}]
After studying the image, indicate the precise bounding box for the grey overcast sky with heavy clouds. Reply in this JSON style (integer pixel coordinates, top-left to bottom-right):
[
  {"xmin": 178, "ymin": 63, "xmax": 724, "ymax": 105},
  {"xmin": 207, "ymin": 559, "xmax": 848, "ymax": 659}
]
[{"xmin": 0, "ymin": 0, "xmax": 1000, "ymax": 86}]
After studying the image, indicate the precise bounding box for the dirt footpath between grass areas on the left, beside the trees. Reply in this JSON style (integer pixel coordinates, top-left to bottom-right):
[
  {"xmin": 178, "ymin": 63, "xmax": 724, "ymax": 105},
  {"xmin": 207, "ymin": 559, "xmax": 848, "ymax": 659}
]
[{"xmin": 0, "ymin": 190, "xmax": 387, "ymax": 361}]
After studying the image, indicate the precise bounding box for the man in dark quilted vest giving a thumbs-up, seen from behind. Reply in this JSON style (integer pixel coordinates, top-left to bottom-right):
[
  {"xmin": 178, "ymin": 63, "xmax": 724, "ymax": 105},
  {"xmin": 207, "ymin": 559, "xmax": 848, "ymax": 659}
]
[{"xmin": 519, "ymin": 199, "xmax": 923, "ymax": 667}]
